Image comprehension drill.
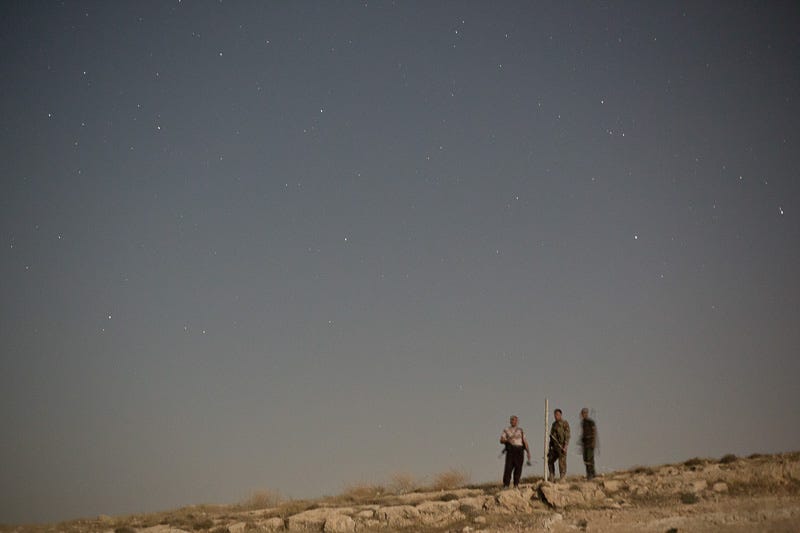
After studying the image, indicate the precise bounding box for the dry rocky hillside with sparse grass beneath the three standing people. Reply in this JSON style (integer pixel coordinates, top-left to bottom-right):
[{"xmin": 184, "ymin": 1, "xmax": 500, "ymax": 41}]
[{"xmin": 0, "ymin": 452, "xmax": 800, "ymax": 533}]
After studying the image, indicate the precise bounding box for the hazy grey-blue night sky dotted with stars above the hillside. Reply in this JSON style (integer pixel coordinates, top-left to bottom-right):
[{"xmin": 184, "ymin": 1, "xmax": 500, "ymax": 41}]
[{"xmin": 0, "ymin": 0, "xmax": 800, "ymax": 523}]
